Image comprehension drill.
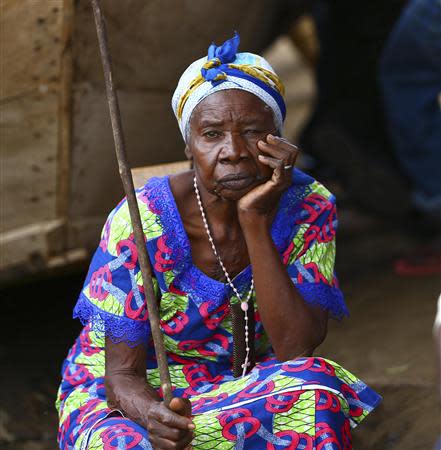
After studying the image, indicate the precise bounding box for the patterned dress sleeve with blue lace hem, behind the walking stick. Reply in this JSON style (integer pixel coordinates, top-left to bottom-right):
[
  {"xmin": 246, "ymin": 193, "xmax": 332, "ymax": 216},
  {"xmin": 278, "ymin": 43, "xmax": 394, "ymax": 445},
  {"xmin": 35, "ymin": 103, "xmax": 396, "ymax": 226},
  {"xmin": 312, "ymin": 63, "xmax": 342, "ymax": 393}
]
[{"xmin": 74, "ymin": 192, "xmax": 158, "ymax": 346}]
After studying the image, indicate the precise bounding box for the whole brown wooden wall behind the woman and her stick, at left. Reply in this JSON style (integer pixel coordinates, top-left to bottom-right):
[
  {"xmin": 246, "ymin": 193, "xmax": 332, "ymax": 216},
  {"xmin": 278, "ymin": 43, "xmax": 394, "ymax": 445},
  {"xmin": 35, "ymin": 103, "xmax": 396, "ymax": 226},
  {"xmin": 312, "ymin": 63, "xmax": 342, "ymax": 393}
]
[{"xmin": 0, "ymin": 0, "xmax": 301, "ymax": 280}]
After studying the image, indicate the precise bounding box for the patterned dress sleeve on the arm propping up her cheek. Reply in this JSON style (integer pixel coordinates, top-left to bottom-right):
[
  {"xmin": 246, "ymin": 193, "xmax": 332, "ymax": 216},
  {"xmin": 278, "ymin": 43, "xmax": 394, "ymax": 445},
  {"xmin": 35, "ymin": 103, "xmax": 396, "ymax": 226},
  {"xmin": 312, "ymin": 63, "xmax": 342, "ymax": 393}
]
[{"xmin": 283, "ymin": 181, "xmax": 348, "ymax": 319}]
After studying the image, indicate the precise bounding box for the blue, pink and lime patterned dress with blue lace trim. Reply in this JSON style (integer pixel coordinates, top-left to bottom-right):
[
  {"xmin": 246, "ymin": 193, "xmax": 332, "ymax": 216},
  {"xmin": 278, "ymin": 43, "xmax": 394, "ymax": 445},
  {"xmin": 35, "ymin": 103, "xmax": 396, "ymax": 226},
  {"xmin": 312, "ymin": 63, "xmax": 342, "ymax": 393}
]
[{"xmin": 57, "ymin": 170, "xmax": 380, "ymax": 450}]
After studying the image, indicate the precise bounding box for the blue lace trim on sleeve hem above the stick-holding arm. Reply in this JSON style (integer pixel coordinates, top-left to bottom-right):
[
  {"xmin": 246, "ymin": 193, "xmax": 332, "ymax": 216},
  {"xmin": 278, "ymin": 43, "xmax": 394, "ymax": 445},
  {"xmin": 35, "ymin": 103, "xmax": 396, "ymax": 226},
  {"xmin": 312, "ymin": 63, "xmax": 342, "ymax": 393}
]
[{"xmin": 73, "ymin": 295, "xmax": 150, "ymax": 347}]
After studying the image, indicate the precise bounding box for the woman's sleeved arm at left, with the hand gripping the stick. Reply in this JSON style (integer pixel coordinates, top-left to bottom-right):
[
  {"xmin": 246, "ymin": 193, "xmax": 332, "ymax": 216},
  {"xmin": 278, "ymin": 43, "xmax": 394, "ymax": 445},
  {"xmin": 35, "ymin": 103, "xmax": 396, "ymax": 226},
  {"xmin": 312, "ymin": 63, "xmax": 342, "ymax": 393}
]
[{"xmin": 74, "ymin": 190, "xmax": 194, "ymax": 449}]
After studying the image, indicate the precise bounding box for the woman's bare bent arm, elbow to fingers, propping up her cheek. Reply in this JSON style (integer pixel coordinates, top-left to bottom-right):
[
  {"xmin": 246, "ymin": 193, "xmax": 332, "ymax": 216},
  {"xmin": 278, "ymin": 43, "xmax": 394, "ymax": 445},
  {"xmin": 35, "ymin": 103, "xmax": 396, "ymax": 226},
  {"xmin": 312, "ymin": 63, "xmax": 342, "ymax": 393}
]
[{"xmin": 237, "ymin": 135, "xmax": 328, "ymax": 361}]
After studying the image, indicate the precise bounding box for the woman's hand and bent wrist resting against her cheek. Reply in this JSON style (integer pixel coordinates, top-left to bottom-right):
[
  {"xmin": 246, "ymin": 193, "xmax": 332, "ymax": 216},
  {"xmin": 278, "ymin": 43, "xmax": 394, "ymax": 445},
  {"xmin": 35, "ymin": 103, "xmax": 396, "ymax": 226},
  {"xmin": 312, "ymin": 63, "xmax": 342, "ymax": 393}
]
[{"xmin": 237, "ymin": 134, "xmax": 298, "ymax": 222}]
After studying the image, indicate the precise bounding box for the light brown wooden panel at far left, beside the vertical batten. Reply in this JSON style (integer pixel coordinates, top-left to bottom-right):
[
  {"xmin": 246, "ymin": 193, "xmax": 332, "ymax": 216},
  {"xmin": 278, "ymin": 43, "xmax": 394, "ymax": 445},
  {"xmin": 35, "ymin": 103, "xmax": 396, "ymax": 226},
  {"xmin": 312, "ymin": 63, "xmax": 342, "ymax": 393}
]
[{"xmin": 0, "ymin": 0, "xmax": 63, "ymax": 236}]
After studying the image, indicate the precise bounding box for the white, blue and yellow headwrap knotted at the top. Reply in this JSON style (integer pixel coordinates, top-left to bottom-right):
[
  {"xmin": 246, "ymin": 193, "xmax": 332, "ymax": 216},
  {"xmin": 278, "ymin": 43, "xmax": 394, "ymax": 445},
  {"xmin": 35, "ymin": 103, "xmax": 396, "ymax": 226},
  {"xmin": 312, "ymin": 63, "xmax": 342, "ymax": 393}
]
[{"xmin": 172, "ymin": 33, "xmax": 286, "ymax": 141}]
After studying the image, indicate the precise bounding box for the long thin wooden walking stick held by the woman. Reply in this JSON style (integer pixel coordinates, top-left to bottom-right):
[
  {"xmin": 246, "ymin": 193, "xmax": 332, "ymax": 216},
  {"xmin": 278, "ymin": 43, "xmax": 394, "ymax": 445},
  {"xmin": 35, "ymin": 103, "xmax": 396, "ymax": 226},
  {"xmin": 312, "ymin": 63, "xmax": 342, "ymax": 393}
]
[{"xmin": 92, "ymin": 0, "xmax": 172, "ymax": 406}]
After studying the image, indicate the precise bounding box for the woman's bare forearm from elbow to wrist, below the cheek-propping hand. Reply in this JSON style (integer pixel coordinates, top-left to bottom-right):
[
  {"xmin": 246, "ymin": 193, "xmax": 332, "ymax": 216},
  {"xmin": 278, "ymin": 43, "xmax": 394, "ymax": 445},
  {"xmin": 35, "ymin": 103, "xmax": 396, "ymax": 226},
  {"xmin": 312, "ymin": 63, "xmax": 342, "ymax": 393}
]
[{"xmin": 237, "ymin": 217, "xmax": 327, "ymax": 360}]
